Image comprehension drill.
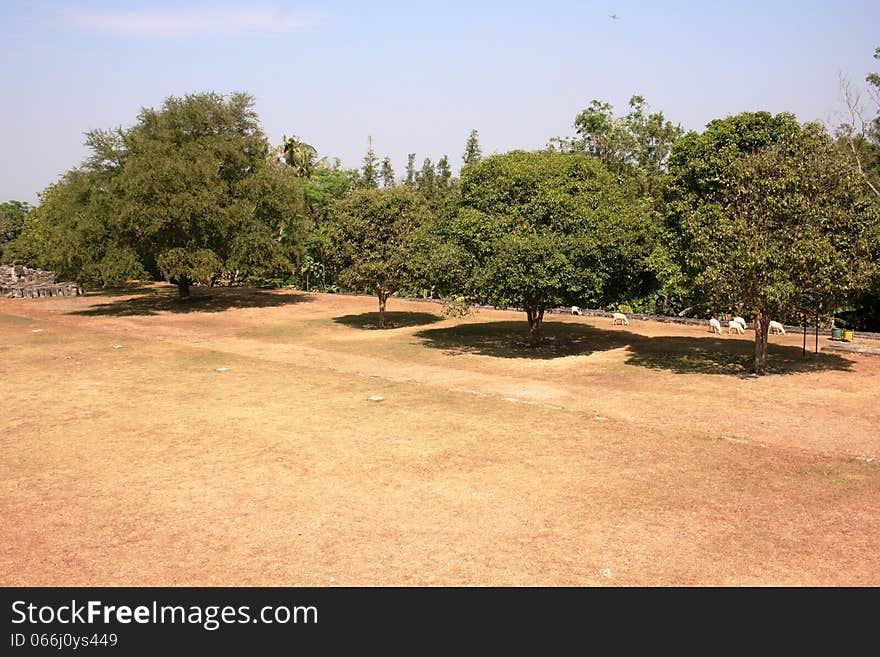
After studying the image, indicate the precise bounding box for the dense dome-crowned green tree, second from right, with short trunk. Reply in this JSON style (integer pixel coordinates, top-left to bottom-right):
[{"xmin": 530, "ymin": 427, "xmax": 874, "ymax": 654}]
[{"xmin": 445, "ymin": 151, "xmax": 654, "ymax": 346}]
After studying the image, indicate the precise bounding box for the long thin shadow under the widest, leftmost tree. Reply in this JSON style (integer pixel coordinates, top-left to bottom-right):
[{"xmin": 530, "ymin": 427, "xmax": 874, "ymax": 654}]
[{"xmin": 70, "ymin": 287, "xmax": 311, "ymax": 317}]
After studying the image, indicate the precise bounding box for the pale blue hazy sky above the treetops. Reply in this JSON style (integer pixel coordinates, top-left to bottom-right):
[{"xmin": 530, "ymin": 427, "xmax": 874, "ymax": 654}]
[{"xmin": 0, "ymin": 0, "xmax": 880, "ymax": 203}]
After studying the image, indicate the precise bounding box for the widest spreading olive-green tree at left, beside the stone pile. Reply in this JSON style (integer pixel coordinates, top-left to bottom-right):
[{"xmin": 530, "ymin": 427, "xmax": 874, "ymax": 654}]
[{"xmin": 16, "ymin": 93, "xmax": 303, "ymax": 297}]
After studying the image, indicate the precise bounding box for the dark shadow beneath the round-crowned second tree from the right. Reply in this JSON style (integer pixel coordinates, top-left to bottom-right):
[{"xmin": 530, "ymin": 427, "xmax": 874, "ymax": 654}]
[{"xmin": 416, "ymin": 321, "xmax": 630, "ymax": 360}]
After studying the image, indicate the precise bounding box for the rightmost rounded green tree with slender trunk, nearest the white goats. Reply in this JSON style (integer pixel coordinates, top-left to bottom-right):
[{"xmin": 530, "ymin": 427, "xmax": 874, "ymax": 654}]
[{"xmin": 666, "ymin": 112, "xmax": 878, "ymax": 373}]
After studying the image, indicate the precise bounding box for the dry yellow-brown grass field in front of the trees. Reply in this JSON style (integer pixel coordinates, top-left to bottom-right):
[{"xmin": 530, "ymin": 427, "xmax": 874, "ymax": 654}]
[{"xmin": 0, "ymin": 286, "xmax": 880, "ymax": 586}]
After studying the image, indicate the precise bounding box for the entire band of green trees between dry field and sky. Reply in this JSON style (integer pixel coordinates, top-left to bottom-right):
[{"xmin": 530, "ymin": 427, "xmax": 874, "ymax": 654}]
[{"xmin": 6, "ymin": 48, "xmax": 880, "ymax": 372}]
